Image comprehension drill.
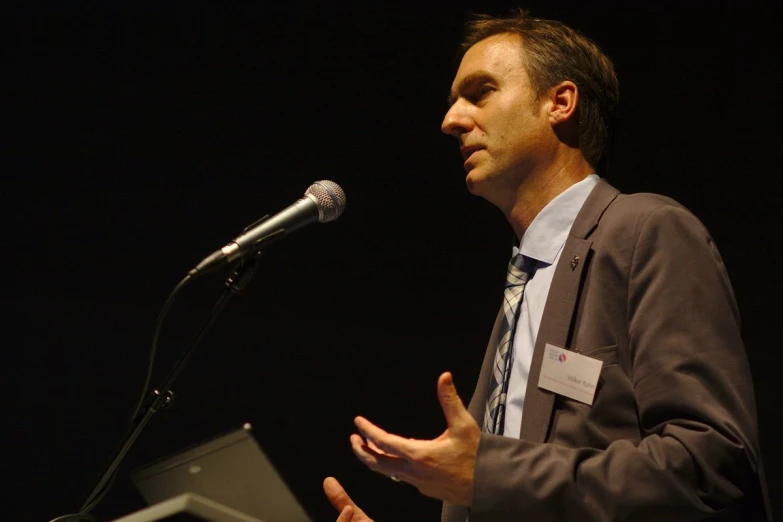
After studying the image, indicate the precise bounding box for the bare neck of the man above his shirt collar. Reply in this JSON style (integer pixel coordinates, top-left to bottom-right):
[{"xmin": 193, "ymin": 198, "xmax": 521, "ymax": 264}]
[{"xmin": 505, "ymin": 155, "xmax": 595, "ymax": 239}]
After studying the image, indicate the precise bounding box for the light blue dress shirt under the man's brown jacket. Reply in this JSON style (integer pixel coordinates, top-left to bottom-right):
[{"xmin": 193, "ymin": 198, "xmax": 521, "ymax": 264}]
[{"xmin": 503, "ymin": 174, "xmax": 600, "ymax": 438}]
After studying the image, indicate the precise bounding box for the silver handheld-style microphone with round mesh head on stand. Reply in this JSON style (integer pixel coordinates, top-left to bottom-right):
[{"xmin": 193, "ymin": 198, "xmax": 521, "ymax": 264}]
[{"xmin": 188, "ymin": 180, "xmax": 345, "ymax": 277}]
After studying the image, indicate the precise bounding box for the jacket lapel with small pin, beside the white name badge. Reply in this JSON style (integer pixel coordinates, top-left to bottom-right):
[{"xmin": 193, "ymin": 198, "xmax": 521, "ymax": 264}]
[{"xmin": 519, "ymin": 181, "xmax": 618, "ymax": 442}]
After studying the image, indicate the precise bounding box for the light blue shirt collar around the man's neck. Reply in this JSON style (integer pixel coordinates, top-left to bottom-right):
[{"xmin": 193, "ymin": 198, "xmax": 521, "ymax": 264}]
[{"xmin": 512, "ymin": 174, "xmax": 601, "ymax": 265}]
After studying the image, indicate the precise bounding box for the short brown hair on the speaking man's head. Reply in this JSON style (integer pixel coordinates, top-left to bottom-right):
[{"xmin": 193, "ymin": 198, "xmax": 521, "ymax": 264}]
[{"xmin": 461, "ymin": 9, "xmax": 619, "ymax": 168}]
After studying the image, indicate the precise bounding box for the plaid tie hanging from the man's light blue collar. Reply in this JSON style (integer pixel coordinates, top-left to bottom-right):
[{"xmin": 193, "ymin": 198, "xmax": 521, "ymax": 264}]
[{"xmin": 482, "ymin": 254, "xmax": 533, "ymax": 435}]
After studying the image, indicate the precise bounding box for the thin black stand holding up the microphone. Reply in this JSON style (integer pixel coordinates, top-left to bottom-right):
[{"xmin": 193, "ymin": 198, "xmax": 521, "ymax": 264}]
[{"xmin": 67, "ymin": 251, "xmax": 261, "ymax": 522}]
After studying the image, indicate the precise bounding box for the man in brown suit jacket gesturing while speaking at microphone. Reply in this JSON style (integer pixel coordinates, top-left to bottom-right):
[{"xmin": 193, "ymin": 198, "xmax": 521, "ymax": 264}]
[{"xmin": 324, "ymin": 11, "xmax": 769, "ymax": 522}]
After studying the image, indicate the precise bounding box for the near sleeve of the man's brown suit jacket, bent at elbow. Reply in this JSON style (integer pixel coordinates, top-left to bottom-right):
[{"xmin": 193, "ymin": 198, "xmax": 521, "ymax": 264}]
[{"xmin": 470, "ymin": 205, "xmax": 758, "ymax": 522}]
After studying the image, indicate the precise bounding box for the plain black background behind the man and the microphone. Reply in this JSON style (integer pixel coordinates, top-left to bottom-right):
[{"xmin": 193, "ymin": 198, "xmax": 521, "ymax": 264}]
[{"xmin": 7, "ymin": 0, "xmax": 783, "ymax": 522}]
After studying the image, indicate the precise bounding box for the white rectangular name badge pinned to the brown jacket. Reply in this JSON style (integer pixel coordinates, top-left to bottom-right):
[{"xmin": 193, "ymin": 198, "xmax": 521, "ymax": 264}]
[{"xmin": 538, "ymin": 343, "xmax": 604, "ymax": 406}]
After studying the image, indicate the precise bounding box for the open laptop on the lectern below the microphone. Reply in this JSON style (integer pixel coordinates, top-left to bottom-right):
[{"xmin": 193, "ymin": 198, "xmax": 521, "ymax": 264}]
[{"xmin": 131, "ymin": 424, "xmax": 312, "ymax": 522}]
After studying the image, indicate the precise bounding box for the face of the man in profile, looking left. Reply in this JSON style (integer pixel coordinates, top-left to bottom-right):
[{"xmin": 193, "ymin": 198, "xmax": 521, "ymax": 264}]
[{"xmin": 441, "ymin": 34, "xmax": 553, "ymax": 210}]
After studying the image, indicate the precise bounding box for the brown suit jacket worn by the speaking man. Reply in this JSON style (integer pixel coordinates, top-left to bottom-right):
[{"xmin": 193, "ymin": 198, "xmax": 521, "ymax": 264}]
[{"xmin": 442, "ymin": 181, "xmax": 771, "ymax": 522}]
